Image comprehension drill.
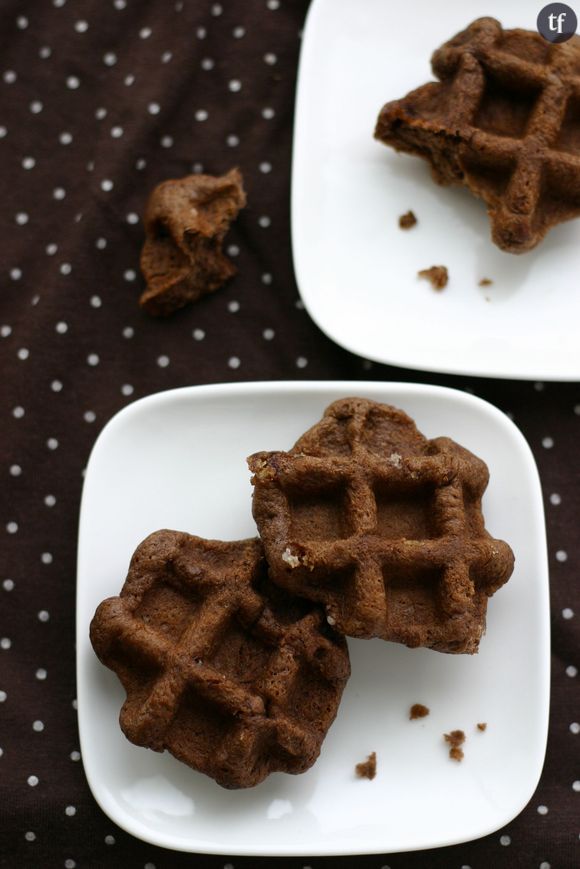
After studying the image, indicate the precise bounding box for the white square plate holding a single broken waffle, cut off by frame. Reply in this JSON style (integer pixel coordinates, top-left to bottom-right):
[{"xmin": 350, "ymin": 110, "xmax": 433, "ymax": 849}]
[{"xmin": 292, "ymin": 0, "xmax": 580, "ymax": 380}]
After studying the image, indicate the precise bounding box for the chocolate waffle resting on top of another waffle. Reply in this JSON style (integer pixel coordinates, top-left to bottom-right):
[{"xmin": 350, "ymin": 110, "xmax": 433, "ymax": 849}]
[{"xmin": 248, "ymin": 398, "xmax": 513, "ymax": 653}]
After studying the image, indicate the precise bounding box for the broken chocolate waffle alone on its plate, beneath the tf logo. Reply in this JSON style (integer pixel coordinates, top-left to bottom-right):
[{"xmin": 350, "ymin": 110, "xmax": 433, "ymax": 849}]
[{"xmin": 375, "ymin": 18, "xmax": 580, "ymax": 253}]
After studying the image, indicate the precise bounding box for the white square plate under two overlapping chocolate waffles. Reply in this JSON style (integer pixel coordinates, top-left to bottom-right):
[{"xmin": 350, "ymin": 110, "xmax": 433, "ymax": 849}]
[{"xmin": 77, "ymin": 382, "xmax": 549, "ymax": 856}]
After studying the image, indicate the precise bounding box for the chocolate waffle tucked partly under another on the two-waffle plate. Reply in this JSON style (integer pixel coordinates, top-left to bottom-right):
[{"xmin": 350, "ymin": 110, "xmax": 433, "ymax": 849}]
[{"xmin": 90, "ymin": 531, "xmax": 350, "ymax": 788}]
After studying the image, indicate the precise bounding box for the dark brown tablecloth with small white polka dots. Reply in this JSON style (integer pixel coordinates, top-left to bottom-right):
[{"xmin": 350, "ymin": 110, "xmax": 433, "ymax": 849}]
[{"xmin": 0, "ymin": 0, "xmax": 580, "ymax": 869}]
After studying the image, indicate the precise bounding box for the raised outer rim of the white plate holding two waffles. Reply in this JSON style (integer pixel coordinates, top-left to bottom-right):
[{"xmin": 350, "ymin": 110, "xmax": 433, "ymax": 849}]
[{"xmin": 75, "ymin": 380, "xmax": 550, "ymax": 857}]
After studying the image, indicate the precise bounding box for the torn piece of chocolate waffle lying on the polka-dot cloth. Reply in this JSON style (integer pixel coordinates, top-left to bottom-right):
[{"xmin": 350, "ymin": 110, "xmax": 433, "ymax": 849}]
[{"xmin": 140, "ymin": 169, "xmax": 246, "ymax": 317}]
